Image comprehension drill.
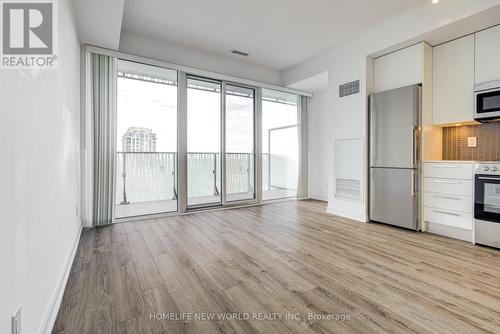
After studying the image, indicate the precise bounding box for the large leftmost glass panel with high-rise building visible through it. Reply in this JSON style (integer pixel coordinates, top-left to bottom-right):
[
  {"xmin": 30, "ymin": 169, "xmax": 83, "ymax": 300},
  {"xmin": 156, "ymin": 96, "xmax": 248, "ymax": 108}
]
[{"xmin": 115, "ymin": 60, "xmax": 177, "ymax": 218}]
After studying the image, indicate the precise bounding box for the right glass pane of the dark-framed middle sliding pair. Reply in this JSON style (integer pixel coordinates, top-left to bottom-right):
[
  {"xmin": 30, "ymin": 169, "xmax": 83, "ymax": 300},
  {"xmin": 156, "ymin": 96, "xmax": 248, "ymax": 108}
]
[{"xmin": 225, "ymin": 85, "xmax": 255, "ymax": 202}]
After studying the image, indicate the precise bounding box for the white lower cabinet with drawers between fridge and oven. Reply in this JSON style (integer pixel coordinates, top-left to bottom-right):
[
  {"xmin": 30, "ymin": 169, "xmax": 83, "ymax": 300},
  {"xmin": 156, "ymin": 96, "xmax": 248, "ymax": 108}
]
[{"xmin": 424, "ymin": 161, "xmax": 474, "ymax": 241}]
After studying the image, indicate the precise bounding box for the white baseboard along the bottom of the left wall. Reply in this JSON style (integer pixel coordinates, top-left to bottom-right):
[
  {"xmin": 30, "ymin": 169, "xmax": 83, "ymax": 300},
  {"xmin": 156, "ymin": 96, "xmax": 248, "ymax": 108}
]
[{"xmin": 38, "ymin": 226, "xmax": 82, "ymax": 334}]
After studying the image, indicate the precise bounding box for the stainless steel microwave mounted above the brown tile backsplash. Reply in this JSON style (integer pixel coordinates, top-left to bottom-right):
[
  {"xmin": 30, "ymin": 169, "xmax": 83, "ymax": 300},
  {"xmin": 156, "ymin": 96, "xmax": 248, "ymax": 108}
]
[{"xmin": 474, "ymin": 81, "xmax": 500, "ymax": 123}]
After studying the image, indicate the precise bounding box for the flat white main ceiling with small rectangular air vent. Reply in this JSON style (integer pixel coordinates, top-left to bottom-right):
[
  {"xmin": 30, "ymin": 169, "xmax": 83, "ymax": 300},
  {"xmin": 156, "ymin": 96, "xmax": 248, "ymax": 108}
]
[{"xmin": 122, "ymin": 0, "xmax": 431, "ymax": 70}]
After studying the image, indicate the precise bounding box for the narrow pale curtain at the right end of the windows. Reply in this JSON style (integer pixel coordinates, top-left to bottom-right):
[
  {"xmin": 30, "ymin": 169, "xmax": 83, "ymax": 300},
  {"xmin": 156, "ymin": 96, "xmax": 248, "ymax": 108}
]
[{"xmin": 297, "ymin": 96, "xmax": 309, "ymax": 198}]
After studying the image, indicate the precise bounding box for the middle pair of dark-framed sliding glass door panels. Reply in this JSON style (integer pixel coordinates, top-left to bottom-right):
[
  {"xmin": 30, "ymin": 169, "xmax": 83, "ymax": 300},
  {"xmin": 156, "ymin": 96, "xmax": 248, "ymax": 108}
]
[{"xmin": 187, "ymin": 77, "xmax": 255, "ymax": 208}]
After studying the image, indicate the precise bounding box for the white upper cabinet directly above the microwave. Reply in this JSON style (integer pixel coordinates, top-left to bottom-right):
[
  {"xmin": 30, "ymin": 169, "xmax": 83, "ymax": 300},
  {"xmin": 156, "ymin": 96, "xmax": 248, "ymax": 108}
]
[{"xmin": 476, "ymin": 26, "xmax": 500, "ymax": 84}]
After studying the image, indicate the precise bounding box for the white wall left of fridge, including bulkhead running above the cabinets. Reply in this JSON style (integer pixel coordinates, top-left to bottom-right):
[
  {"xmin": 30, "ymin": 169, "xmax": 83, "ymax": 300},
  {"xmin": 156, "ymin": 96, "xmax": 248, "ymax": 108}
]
[{"xmin": 283, "ymin": 0, "xmax": 500, "ymax": 221}]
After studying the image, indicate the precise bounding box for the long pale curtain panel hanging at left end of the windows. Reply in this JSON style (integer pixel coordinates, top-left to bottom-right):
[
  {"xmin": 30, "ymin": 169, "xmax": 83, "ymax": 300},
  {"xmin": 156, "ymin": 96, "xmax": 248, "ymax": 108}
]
[{"xmin": 86, "ymin": 52, "xmax": 117, "ymax": 226}]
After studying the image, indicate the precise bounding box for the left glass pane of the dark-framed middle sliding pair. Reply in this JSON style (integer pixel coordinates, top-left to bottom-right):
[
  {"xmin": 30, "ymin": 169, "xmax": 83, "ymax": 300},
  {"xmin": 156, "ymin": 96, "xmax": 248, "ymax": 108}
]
[{"xmin": 187, "ymin": 77, "xmax": 222, "ymax": 207}]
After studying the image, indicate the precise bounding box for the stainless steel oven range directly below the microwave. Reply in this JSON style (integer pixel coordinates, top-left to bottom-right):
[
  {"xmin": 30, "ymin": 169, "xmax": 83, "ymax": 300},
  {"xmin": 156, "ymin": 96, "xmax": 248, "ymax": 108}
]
[{"xmin": 474, "ymin": 163, "xmax": 500, "ymax": 248}]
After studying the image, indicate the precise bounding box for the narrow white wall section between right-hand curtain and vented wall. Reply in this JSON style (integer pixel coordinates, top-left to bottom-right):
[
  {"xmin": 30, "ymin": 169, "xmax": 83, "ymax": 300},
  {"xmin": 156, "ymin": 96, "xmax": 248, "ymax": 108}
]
[{"xmin": 309, "ymin": 90, "xmax": 329, "ymax": 201}]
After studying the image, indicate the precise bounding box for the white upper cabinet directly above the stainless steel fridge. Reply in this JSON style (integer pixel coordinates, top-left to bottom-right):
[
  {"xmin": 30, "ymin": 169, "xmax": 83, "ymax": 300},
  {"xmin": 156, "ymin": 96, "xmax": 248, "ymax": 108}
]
[{"xmin": 373, "ymin": 43, "xmax": 423, "ymax": 92}]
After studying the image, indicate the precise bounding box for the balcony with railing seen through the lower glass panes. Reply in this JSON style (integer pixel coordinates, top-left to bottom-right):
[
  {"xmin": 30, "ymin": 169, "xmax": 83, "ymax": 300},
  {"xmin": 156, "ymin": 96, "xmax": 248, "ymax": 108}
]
[{"xmin": 115, "ymin": 152, "xmax": 296, "ymax": 218}]
